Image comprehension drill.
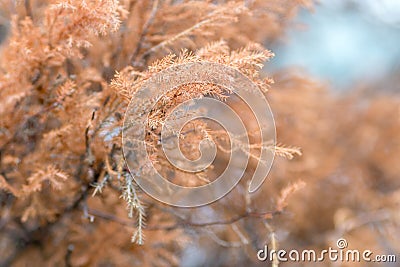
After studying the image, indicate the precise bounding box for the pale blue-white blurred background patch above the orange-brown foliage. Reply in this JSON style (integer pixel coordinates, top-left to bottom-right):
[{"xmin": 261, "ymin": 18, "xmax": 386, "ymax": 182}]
[{"xmin": 267, "ymin": 0, "xmax": 400, "ymax": 90}]
